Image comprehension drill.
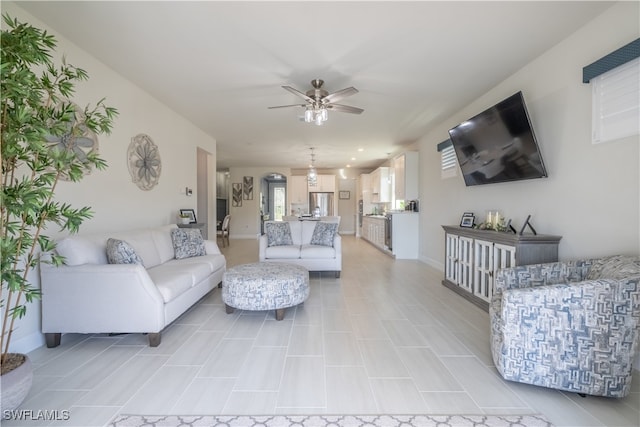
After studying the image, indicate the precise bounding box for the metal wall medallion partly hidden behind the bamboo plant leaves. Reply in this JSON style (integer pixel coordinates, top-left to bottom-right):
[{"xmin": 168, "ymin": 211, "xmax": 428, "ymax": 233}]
[{"xmin": 45, "ymin": 103, "xmax": 99, "ymax": 181}]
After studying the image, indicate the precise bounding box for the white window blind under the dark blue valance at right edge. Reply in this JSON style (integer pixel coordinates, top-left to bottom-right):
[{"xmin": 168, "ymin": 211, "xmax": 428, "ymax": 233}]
[{"xmin": 591, "ymin": 58, "xmax": 640, "ymax": 144}]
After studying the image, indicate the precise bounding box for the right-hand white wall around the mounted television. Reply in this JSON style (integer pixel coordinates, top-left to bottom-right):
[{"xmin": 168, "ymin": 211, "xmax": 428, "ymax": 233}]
[{"xmin": 420, "ymin": 2, "xmax": 640, "ymax": 269}]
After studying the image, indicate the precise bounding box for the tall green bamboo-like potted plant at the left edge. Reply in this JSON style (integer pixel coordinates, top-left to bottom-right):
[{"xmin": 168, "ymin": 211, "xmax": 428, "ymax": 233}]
[{"xmin": 0, "ymin": 14, "xmax": 117, "ymax": 410}]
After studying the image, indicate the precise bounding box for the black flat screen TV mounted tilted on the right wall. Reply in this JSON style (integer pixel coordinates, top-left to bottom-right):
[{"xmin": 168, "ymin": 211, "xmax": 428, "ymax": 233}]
[{"xmin": 449, "ymin": 92, "xmax": 547, "ymax": 186}]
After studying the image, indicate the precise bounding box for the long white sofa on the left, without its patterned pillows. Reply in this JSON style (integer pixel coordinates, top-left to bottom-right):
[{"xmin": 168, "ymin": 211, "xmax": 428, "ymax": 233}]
[{"xmin": 40, "ymin": 225, "xmax": 226, "ymax": 347}]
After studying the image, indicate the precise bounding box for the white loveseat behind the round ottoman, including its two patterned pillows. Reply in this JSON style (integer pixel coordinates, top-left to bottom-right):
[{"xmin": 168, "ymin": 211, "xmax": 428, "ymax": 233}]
[{"xmin": 259, "ymin": 221, "xmax": 342, "ymax": 277}]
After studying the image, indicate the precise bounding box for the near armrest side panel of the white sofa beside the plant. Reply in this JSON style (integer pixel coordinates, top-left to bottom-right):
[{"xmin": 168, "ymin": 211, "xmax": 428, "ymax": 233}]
[{"xmin": 40, "ymin": 264, "xmax": 165, "ymax": 333}]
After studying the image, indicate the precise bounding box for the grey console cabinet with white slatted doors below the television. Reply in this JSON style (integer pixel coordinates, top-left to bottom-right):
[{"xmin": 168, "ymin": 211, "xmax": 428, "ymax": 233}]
[{"xmin": 442, "ymin": 225, "xmax": 562, "ymax": 311}]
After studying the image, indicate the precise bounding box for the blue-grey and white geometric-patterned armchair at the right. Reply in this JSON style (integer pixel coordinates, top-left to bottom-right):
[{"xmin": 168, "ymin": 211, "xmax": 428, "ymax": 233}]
[{"xmin": 489, "ymin": 255, "xmax": 640, "ymax": 397}]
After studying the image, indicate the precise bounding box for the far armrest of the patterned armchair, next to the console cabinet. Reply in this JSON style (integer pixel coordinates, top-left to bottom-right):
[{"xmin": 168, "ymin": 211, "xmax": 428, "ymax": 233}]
[{"xmin": 494, "ymin": 260, "xmax": 593, "ymax": 292}]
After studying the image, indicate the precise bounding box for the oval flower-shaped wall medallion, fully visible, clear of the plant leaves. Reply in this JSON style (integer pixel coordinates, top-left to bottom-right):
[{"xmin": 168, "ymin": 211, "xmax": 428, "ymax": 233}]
[{"xmin": 127, "ymin": 133, "xmax": 162, "ymax": 191}]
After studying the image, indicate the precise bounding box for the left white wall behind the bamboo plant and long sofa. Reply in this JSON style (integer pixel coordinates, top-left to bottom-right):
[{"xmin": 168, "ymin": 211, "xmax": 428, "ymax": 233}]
[{"xmin": 3, "ymin": 3, "xmax": 216, "ymax": 352}]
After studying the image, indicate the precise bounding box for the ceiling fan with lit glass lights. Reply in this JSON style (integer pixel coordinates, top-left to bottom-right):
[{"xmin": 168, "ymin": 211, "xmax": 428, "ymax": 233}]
[{"xmin": 269, "ymin": 79, "xmax": 364, "ymax": 125}]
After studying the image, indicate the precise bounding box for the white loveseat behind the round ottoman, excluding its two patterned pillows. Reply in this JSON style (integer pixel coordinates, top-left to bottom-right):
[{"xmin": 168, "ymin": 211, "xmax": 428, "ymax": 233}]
[{"xmin": 259, "ymin": 221, "xmax": 342, "ymax": 277}]
